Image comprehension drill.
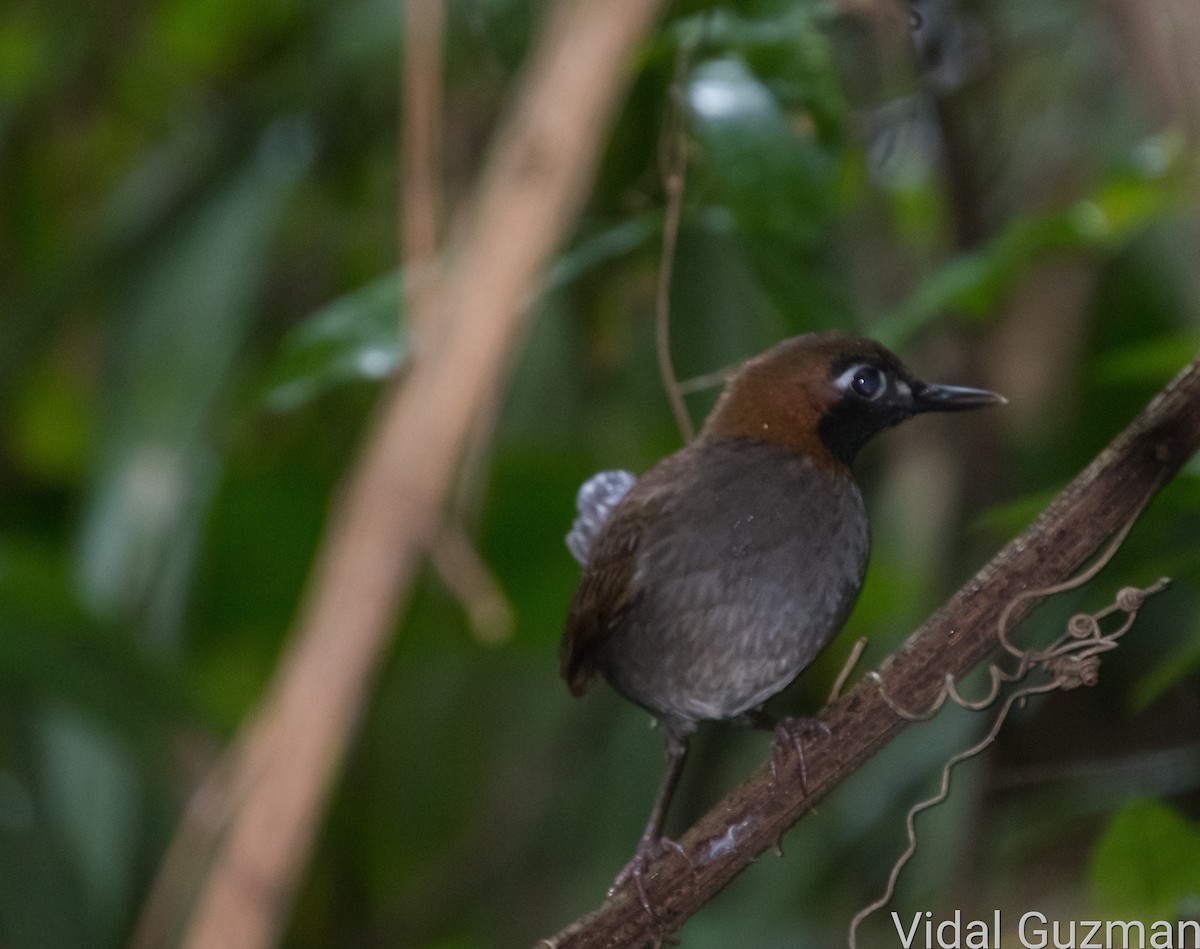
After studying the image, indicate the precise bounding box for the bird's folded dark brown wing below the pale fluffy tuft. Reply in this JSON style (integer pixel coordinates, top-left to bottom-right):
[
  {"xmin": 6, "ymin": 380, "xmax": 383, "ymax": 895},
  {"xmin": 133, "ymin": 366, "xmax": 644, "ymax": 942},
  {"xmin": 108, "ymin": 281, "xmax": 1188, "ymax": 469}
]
[{"xmin": 558, "ymin": 496, "xmax": 644, "ymax": 696}]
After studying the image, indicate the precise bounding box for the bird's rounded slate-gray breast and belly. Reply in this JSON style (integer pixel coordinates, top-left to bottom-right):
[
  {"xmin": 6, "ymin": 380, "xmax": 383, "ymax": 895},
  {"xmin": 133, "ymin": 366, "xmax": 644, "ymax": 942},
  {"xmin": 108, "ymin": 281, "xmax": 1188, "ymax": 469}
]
[{"xmin": 601, "ymin": 442, "xmax": 869, "ymax": 728}]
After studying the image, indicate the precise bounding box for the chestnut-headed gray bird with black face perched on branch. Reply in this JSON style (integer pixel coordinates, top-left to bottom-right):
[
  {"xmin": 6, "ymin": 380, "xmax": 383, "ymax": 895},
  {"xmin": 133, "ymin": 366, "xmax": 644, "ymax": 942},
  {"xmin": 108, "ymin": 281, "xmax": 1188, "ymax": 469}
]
[{"xmin": 559, "ymin": 332, "xmax": 1006, "ymax": 917}]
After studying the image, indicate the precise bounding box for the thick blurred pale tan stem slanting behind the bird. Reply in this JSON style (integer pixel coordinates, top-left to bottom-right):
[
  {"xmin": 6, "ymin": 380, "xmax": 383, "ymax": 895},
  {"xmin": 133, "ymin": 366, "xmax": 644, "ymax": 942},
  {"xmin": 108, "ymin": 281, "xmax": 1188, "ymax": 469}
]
[{"xmin": 150, "ymin": 0, "xmax": 661, "ymax": 949}]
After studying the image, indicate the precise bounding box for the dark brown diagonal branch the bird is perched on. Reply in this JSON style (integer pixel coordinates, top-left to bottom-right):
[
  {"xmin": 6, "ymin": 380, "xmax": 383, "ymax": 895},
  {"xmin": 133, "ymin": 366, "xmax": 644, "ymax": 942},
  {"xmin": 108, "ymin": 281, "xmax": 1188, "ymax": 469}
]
[{"xmin": 539, "ymin": 358, "xmax": 1200, "ymax": 949}]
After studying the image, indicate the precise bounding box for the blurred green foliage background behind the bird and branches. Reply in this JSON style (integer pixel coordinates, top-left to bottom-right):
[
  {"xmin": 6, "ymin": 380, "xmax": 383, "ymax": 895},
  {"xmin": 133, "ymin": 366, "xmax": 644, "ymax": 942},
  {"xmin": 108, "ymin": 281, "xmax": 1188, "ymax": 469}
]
[{"xmin": 0, "ymin": 0, "xmax": 1200, "ymax": 949}]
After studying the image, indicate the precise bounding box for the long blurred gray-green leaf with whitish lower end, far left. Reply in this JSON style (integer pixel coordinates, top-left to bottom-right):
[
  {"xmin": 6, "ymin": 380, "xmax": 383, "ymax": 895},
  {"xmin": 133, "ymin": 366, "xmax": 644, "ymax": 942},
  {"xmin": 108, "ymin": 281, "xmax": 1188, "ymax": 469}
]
[{"xmin": 79, "ymin": 119, "xmax": 312, "ymax": 648}]
